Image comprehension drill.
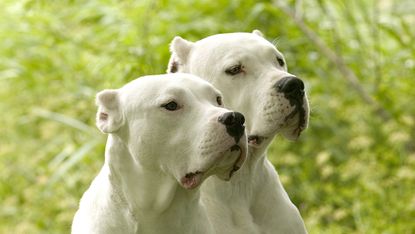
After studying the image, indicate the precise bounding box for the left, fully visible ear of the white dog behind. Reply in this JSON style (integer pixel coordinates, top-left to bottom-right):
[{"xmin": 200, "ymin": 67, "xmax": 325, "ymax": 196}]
[{"xmin": 167, "ymin": 36, "xmax": 194, "ymax": 73}]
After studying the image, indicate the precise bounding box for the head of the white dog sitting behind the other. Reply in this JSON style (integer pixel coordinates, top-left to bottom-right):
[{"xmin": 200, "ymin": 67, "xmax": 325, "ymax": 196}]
[{"xmin": 168, "ymin": 30, "xmax": 309, "ymax": 151}]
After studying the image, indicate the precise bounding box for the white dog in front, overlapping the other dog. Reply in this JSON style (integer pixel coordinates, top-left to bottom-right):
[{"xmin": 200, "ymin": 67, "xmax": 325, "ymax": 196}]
[{"xmin": 72, "ymin": 74, "xmax": 247, "ymax": 234}]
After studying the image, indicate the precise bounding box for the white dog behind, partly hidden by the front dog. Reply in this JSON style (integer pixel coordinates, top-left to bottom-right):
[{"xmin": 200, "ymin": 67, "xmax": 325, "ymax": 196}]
[{"xmin": 168, "ymin": 30, "xmax": 309, "ymax": 234}]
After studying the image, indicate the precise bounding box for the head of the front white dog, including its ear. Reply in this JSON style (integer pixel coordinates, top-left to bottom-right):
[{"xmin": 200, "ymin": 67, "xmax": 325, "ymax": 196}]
[{"xmin": 96, "ymin": 74, "xmax": 247, "ymax": 189}]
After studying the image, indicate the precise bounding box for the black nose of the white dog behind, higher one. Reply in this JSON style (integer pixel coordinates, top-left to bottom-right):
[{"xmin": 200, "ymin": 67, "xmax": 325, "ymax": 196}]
[{"xmin": 275, "ymin": 76, "xmax": 304, "ymax": 99}]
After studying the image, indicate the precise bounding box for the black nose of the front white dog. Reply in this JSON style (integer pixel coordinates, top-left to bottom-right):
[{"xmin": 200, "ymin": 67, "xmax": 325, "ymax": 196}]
[{"xmin": 218, "ymin": 112, "xmax": 245, "ymax": 143}]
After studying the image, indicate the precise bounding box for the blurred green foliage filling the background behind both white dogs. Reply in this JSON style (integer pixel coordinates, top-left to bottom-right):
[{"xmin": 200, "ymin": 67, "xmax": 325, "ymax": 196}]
[{"xmin": 0, "ymin": 0, "xmax": 415, "ymax": 234}]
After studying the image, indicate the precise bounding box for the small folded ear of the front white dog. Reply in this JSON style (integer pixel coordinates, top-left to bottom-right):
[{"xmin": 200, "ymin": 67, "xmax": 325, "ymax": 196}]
[{"xmin": 95, "ymin": 89, "xmax": 124, "ymax": 133}]
